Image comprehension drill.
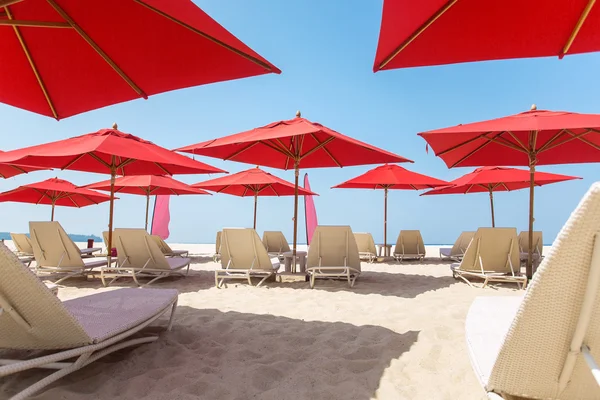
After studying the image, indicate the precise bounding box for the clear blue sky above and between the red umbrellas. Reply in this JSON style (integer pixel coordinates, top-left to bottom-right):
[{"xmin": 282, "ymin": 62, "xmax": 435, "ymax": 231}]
[{"xmin": 0, "ymin": 0, "xmax": 600, "ymax": 244}]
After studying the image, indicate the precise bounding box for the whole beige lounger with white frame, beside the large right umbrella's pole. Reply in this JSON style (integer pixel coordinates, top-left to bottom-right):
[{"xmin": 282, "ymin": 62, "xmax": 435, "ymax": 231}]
[{"xmin": 450, "ymin": 228, "xmax": 527, "ymax": 289}]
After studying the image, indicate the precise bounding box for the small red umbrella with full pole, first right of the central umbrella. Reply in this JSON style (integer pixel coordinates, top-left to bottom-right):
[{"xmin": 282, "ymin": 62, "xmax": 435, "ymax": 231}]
[{"xmin": 332, "ymin": 164, "xmax": 448, "ymax": 253}]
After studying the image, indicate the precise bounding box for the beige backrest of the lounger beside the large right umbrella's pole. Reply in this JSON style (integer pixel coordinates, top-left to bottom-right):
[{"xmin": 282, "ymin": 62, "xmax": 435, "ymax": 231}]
[{"xmin": 460, "ymin": 228, "xmax": 521, "ymax": 274}]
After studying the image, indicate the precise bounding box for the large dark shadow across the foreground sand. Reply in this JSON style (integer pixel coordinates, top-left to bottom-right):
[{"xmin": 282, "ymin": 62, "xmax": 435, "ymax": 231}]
[{"xmin": 0, "ymin": 306, "xmax": 419, "ymax": 400}]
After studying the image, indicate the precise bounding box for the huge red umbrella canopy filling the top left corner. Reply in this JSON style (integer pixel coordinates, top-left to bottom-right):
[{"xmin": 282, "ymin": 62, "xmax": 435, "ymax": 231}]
[{"xmin": 0, "ymin": 0, "xmax": 280, "ymax": 119}]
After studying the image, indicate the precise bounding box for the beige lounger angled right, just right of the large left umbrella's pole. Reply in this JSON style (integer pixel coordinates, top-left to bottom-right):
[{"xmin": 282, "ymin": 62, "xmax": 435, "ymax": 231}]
[{"xmin": 100, "ymin": 228, "xmax": 192, "ymax": 286}]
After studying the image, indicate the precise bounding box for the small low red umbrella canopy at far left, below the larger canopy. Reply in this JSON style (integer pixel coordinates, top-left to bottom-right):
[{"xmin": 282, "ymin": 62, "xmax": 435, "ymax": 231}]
[{"xmin": 0, "ymin": 178, "xmax": 110, "ymax": 221}]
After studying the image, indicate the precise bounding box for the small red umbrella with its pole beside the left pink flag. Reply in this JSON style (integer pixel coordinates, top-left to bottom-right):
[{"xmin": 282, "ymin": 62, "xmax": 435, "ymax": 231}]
[{"xmin": 85, "ymin": 175, "xmax": 210, "ymax": 230}]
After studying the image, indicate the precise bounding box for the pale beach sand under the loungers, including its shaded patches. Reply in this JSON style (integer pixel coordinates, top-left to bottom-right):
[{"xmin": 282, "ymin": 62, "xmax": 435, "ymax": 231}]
[{"xmin": 0, "ymin": 253, "xmax": 523, "ymax": 400}]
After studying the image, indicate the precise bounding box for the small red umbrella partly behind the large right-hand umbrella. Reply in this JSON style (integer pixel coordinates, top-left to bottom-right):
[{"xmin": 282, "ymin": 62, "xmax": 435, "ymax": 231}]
[{"xmin": 421, "ymin": 167, "xmax": 581, "ymax": 227}]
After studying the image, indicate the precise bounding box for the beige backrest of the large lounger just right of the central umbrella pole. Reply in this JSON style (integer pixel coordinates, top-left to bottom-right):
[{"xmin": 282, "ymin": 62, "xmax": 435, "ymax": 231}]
[{"xmin": 306, "ymin": 225, "xmax": 360, "ymax": 271}]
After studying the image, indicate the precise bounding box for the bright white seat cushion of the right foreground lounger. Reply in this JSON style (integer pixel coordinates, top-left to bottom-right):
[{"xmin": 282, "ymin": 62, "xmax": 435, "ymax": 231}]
[{"xmin": 465, "ymin": 296, "xmax": 523, "ymax": 388}]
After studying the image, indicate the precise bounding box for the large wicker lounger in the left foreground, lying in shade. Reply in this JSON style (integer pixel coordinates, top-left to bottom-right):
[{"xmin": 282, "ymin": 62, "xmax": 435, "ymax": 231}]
[{"xmin": 0, "ymin": 244, "xmax": 178, "ymax": 400}]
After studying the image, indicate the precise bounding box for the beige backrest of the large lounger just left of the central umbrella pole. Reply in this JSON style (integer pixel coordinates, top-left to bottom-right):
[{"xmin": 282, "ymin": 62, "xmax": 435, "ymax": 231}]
[{"xmin": 221, "ymin": 228, "xmax": 273, "ymax": 271}]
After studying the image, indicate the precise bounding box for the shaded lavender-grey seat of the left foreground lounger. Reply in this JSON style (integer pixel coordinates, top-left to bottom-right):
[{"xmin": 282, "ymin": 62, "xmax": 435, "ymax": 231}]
[{"xmin": 63, "ymin": 288, "xmax": 178, "ymax": 343}]
